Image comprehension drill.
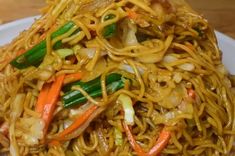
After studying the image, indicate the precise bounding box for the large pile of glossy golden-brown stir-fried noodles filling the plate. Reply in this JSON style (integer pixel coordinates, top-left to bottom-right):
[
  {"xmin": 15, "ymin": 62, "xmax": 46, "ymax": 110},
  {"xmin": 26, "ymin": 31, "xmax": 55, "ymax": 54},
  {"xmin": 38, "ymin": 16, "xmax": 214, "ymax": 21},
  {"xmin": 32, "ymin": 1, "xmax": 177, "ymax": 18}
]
[{"xmin": 0, "ymin": 0, "xmax": 235, "ymax": 156}]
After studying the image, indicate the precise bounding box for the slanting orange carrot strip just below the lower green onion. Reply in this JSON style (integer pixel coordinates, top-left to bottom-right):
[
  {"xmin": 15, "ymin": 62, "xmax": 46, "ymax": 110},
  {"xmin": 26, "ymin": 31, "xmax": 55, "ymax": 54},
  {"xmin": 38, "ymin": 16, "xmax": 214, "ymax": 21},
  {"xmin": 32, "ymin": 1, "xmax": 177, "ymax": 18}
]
[{"xmin": 57, "ymin": 105, "xmax": 98, "ymax": 140}]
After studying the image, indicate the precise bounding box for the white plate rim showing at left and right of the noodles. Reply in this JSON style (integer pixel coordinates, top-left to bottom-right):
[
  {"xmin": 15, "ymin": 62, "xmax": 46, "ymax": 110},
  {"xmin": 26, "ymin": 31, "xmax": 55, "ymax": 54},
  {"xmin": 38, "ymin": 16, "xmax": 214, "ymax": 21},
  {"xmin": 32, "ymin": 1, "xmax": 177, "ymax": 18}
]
[{"xmin": 0, "ymin": 16, "xmax": 235, "ymax": 74}]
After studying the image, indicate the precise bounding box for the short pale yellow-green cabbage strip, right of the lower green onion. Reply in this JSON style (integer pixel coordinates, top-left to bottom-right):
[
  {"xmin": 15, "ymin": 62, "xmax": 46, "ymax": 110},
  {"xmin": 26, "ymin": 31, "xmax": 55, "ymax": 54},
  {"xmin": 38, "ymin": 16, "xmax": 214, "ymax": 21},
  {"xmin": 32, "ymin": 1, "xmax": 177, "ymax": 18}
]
[{"xmin": 117, "ymin": 94, "xmax": 135, "ymax": 125}]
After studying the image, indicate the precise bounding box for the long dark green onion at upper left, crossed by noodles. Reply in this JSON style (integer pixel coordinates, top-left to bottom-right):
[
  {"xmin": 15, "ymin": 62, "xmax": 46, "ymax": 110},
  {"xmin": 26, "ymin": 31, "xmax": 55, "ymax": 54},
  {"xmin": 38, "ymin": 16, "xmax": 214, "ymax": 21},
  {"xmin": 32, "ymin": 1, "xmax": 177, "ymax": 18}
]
[{"xmin": 11, "ymin": 21, "xmax": 75, "ymax": 69}]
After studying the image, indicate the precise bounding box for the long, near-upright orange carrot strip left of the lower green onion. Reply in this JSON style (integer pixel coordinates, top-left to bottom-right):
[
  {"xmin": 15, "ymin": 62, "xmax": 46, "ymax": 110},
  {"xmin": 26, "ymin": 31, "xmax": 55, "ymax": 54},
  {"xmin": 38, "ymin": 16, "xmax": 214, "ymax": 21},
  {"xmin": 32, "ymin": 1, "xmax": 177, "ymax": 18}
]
[{"xmin": 42, "ymin": 75, "xmax": 65, "ymax": 134}]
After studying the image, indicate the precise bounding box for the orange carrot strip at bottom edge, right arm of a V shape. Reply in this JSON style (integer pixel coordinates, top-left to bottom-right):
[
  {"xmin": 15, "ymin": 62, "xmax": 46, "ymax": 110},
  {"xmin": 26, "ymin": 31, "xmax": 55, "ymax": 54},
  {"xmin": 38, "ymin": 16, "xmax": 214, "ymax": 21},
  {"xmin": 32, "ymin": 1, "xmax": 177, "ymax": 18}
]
[{"xmin": 148, "ymin": 129, "xmax": 171, "ymax": 156}]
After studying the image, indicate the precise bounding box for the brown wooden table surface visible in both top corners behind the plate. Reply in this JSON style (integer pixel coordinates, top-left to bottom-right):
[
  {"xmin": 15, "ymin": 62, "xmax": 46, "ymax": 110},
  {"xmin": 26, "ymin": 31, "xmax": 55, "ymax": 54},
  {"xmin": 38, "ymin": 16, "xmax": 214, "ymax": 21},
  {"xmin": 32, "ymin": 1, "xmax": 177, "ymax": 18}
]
[{"xmin": 0, "ymin": 0, "xmax": 235, "ymax": 39}]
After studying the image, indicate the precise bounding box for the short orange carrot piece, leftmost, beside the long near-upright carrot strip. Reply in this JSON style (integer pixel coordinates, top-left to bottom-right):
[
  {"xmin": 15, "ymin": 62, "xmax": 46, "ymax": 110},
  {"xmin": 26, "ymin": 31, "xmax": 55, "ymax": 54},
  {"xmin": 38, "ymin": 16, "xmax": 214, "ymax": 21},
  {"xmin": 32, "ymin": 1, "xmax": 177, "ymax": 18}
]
[{"xmin": 35, "ymin": 83, "xmax": 50, "ymax": 114}]
